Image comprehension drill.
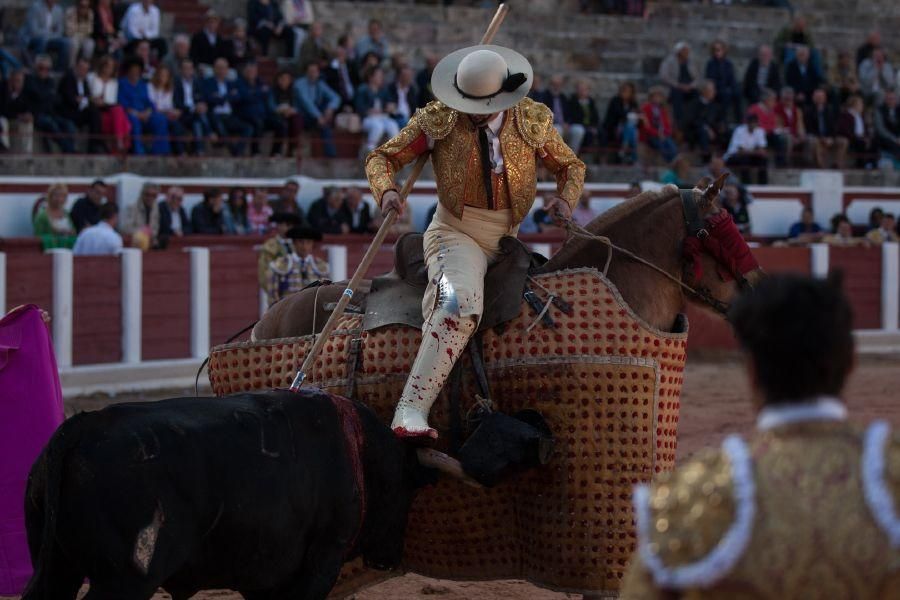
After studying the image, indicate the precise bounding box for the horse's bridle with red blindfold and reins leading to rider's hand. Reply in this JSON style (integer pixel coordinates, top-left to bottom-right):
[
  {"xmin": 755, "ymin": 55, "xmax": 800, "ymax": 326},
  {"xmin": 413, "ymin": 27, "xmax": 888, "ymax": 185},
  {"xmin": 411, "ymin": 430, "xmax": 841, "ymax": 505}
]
[{"xmin": 565, "ymin": 188, "xmax": 759, "ymax": 318}]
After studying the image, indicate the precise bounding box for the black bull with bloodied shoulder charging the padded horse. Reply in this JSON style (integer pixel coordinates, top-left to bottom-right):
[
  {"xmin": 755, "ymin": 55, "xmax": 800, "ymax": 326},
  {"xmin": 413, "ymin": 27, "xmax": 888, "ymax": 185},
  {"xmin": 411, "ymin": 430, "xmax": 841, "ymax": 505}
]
[{"xmin": 23, "ymin": 390, "xmax": 427, "ymax": 600}]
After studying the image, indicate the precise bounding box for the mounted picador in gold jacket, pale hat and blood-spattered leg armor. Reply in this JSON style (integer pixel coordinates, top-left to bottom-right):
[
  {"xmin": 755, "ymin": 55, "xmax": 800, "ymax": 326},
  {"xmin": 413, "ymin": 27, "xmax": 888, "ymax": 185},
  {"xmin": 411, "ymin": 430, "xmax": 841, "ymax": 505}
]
[{"xmin": 366, "ymin": 45, "xmax": 584, "ymax": 438}]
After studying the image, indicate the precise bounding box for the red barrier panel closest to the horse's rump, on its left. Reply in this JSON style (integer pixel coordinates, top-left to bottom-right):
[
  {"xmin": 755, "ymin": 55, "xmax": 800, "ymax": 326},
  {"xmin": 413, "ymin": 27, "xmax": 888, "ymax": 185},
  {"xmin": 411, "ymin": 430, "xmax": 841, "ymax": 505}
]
[{"xmin": 209, "ymin": 248, "xmax": 259, "ymax": 345}]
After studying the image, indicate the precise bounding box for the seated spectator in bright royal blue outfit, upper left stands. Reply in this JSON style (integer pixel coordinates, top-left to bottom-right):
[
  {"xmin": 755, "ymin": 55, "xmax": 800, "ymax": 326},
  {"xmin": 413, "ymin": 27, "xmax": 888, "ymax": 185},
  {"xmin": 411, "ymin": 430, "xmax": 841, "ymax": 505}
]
[{"xmin": 119, "ymin": 57, "xmax": 170, "ymax": 155}]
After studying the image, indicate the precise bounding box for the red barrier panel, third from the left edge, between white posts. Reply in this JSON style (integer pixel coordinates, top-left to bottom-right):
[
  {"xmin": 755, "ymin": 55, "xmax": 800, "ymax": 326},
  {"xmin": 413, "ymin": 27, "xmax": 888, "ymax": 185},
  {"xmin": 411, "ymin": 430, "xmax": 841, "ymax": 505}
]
[{"xmin": 141, "ymin": 252, "xmax": 191, "ymax": 360}]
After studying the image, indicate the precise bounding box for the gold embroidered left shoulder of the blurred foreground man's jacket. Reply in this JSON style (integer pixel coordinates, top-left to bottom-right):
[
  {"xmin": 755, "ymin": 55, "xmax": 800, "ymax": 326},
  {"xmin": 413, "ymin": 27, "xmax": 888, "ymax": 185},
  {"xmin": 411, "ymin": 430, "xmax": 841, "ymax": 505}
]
[{"xmin": 649, "ymin": 450, "xmax": 735, "ymax": 567}]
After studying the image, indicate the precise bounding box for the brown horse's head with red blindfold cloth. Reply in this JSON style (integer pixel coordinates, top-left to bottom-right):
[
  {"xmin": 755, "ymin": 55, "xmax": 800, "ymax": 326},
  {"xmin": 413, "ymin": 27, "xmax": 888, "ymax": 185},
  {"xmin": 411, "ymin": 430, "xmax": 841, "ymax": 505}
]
[{"xmin": 681, "ymin": 173, "xmax": 765, "ymax": 314}]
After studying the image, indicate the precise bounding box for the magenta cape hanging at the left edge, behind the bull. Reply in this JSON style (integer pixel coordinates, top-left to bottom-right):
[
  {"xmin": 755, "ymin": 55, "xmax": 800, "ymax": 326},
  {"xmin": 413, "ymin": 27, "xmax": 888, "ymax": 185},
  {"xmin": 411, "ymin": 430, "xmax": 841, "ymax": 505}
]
[{"xmin": 0, "ymin": 304, "xmax": 63, "ymax": 596}]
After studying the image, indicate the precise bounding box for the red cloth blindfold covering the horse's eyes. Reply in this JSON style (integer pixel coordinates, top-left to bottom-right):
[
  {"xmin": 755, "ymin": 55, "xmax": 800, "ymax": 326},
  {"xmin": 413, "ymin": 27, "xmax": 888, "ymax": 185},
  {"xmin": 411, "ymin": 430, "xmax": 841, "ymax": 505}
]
[{"xmin": 683, "ymin": 210, "xmax": 759, "ymax": 284}]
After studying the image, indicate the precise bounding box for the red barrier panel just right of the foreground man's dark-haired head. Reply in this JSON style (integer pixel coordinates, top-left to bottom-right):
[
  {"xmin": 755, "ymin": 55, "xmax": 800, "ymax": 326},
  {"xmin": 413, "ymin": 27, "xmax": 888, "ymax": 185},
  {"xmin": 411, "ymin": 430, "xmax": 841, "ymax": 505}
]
[{"xmin": 828, "ymin": 247, "xmax": 881, "ymax": 329}]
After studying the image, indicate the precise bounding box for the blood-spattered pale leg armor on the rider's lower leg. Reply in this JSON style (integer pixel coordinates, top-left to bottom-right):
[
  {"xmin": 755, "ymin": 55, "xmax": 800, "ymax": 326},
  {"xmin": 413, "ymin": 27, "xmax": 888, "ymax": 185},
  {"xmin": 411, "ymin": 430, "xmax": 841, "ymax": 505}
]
[{"xmin": 391, "ymin": 274, "xmax": 477, "ymax": 439}]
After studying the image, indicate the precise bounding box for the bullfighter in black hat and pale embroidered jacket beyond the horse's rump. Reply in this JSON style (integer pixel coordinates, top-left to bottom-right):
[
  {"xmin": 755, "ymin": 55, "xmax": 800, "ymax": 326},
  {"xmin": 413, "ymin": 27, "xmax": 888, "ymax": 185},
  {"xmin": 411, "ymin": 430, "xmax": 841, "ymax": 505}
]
[{"xmin": 266, "ymin": 227, "xmax": 328, "ymax": 305}]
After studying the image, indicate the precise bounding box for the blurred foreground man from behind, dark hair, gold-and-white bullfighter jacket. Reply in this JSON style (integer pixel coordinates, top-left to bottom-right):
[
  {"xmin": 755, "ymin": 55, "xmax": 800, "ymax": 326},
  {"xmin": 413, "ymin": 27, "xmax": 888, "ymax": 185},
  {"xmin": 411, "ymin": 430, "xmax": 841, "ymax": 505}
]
[{"xmin": 621, "ymin": 276, "xmax": 900, "ymax": 600}]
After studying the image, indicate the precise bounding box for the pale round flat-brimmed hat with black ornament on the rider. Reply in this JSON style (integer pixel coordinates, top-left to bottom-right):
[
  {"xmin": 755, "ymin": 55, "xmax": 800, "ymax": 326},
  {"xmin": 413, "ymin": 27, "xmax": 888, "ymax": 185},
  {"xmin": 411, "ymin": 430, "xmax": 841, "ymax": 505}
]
[{"xmin": 431, "ymin": 45, "xmax": 534, "ymax": 115}]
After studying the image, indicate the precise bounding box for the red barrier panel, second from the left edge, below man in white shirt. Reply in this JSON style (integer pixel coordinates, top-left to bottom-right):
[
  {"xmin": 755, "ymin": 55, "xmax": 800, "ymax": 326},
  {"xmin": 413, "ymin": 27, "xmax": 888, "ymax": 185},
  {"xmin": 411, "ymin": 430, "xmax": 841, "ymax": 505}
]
[{"xmin": 72, "ymin": 256, "xmax": 122, "ymax": 365}]
